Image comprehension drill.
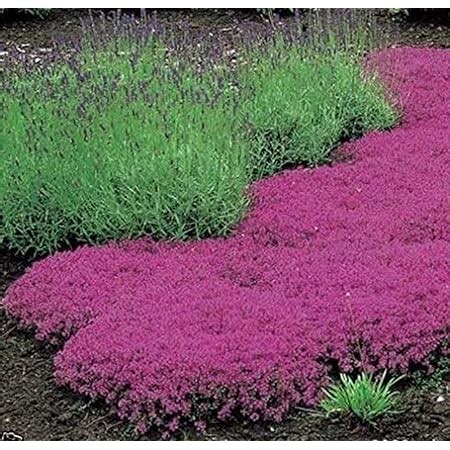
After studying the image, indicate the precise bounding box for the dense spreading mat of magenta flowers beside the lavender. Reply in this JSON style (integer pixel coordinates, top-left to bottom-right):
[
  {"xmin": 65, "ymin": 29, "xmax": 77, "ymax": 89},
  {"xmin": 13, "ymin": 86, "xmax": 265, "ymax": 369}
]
[{"xmin": 4, "ymin": 48, "xmax": 450, "ymax": 431}]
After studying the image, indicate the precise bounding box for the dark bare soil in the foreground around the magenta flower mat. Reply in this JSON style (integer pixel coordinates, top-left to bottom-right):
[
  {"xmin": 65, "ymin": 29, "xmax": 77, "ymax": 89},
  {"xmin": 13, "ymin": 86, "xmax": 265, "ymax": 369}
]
[{"xmin": 0, "ymin": 255, "xmax": 450, "ymax": 440}]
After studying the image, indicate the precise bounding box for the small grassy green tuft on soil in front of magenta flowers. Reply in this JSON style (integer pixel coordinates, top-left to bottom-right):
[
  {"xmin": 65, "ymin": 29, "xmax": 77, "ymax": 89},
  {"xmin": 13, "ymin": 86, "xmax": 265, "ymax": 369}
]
[{"xmin": 320, "ymin": 371, "xmax": 402, "ymax": 423}]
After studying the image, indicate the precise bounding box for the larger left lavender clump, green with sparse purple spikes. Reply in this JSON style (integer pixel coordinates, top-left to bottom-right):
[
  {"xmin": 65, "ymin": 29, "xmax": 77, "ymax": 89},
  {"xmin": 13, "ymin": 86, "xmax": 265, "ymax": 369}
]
[{"xmin": 0, "ymin": 39, "xmax": 248, "ymax": 252}]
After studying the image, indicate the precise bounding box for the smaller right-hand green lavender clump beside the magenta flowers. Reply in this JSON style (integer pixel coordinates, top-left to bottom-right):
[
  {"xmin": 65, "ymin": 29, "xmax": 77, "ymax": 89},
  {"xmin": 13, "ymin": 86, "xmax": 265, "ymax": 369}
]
[{"xmin": 241, "ymin": 33, "xmax": 397, "ymax": 178}]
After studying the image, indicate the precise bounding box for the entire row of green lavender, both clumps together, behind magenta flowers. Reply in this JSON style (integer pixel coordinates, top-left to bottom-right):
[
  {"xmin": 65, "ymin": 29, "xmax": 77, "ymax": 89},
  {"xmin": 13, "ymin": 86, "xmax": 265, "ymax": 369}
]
[{"xmin": 0, "ymin": 13, "xmax": 396, "ymax": 253}]
